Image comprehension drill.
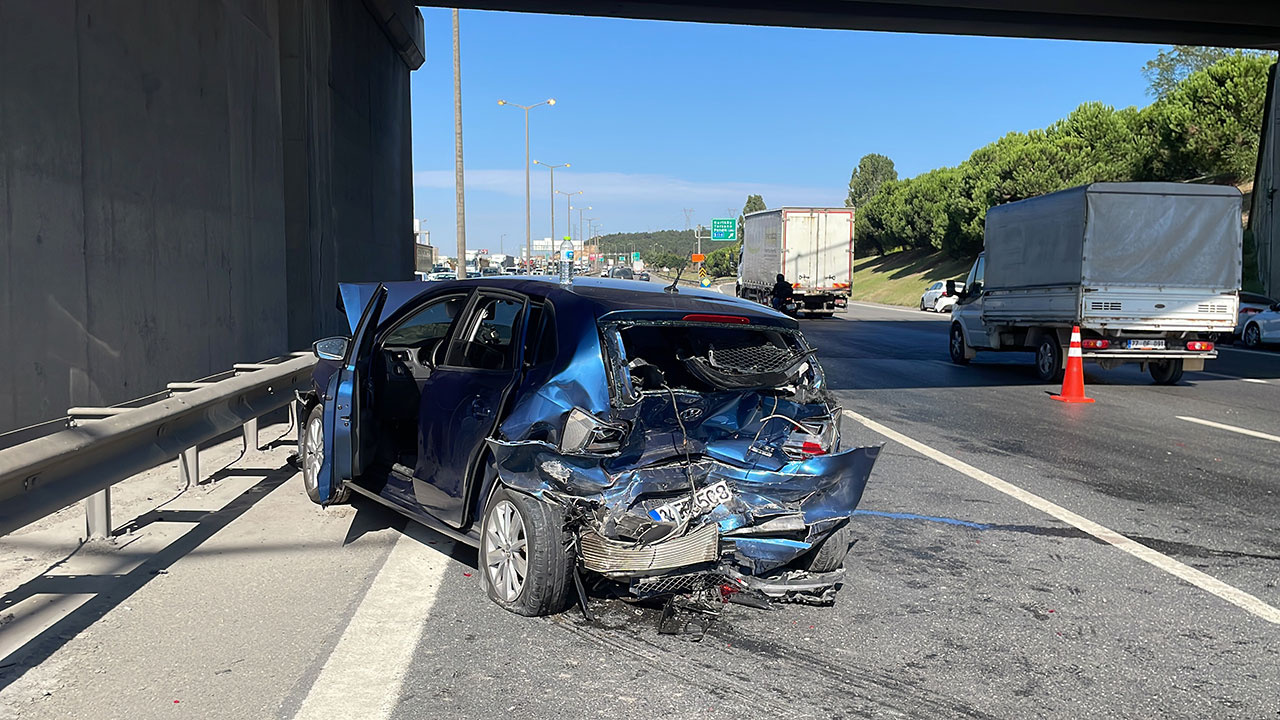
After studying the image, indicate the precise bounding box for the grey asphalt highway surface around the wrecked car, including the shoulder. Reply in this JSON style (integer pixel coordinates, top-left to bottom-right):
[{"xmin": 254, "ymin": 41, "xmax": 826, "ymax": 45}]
[{"xmin": 0, "ymin": 299, "xmax": 1280, "ymax": 719}]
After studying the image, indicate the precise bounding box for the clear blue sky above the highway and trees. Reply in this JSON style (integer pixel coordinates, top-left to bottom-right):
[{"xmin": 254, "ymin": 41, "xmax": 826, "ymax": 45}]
[{"xmin": 410, "ymin": 8, "xmax": 1158, "ymax": 255}]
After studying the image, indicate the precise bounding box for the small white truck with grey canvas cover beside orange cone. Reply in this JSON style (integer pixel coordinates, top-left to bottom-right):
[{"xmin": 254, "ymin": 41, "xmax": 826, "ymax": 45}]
[{"xmin": 948, "ymin": 182, "xmax": 1243, "ymax": 384}]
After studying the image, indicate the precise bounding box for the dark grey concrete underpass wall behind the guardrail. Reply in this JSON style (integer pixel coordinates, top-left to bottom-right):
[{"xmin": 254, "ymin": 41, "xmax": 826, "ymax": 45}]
[{"xmin": 0, "ymin": 0, "xmax": 421, "ymax": 432}]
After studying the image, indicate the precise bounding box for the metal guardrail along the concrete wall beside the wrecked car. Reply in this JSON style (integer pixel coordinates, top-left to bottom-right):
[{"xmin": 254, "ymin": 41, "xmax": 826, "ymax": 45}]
[{"xmin": 0, "ymin": 352, "xmax": 316, "ymax": 538}]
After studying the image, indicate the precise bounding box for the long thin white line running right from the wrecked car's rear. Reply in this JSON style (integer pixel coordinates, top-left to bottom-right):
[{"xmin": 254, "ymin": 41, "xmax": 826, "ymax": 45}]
[{"xmin": 845, "ymin": 410, "xmax": 1280, "ymax": 625}]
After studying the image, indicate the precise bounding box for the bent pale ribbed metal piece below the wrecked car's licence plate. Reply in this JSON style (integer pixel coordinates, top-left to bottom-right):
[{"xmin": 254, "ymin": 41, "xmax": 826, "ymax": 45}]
[{"xmin": 580, "ymin": 523, "xmax": 719, "ymax": 577}]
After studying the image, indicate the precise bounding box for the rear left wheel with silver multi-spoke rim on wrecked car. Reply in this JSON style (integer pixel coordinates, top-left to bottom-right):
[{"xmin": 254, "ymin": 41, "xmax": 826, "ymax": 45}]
[{"xmin": 479, "ymin": 487, "xmax": 573, "ymax": 618}]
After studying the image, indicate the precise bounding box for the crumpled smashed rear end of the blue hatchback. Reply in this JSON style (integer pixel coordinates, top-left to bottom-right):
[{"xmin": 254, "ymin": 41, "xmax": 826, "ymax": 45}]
[{"xmin": 490, "ymin": 315, "xmax": 879, "ymax": 602}]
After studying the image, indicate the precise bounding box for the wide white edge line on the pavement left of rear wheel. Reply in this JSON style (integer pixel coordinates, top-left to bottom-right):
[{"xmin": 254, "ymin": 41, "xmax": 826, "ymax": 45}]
[{"xmin": 294, "ymin": 521, "xmax": 449, "ymax": 720}]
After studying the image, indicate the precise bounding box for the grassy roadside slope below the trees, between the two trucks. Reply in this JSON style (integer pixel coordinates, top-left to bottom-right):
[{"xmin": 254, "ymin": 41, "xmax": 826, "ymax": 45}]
[{"xmin": 851, "ymin": 250, "xmax": 973, "ymax": 307}]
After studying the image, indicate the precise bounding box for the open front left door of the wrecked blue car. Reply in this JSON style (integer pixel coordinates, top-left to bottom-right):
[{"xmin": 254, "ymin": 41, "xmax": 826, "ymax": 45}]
[{"xmin": 316, "ymin": 284, "xmax": 387, "ymax": 502}]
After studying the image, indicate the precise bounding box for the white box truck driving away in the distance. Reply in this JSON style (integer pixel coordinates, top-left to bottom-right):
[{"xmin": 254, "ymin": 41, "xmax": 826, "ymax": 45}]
[{"xmin": 737, "ymin": 208, "xmax": 854, "ymax": 315}]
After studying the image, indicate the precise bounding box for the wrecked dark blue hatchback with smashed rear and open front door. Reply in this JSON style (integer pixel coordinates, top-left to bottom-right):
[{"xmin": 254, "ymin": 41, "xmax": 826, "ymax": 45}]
[{"xmin": 298, "ymin": 277, "xmax": 878, "ymax": 615}]
